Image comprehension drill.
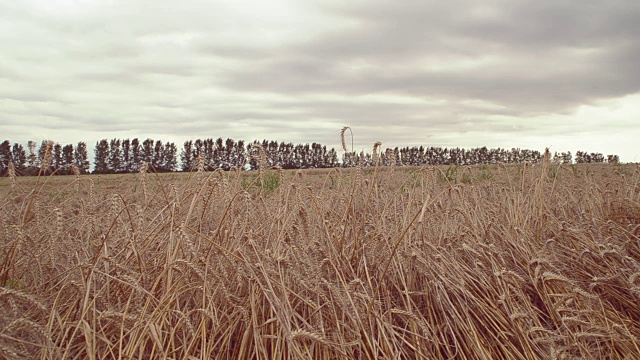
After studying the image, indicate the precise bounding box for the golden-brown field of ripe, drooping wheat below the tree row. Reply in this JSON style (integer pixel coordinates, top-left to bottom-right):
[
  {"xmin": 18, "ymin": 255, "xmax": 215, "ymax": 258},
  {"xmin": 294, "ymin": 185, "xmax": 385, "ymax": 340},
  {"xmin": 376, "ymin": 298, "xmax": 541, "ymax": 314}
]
[{"xmin": 0, "ymin": 162, "xmax": 640, "ymax": 359}]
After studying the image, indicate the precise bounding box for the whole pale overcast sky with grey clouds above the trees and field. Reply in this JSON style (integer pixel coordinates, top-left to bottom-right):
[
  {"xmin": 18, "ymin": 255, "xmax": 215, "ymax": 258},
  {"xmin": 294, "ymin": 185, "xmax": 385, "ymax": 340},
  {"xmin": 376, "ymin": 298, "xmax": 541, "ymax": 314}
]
[{"xmin": 0, "ymin": 0, "xmax": 640, "ymax": 162}]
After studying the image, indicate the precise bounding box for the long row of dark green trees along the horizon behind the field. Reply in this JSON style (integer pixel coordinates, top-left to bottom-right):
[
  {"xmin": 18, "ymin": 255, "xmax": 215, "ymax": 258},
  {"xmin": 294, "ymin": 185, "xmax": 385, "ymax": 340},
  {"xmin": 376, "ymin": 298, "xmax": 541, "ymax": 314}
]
[{"xmin": 0, "ymin": 138, "xmax": 619, "ymax": 175}]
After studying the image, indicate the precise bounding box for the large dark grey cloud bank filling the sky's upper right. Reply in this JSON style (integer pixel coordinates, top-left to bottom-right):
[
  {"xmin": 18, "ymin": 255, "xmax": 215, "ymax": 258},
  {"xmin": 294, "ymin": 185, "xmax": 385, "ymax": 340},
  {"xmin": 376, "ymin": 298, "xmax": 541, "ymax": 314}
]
[{"xmin": 212, "ymin": 1, "xmax": 640, "ymax": 115}]
